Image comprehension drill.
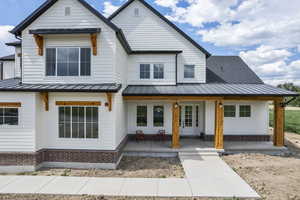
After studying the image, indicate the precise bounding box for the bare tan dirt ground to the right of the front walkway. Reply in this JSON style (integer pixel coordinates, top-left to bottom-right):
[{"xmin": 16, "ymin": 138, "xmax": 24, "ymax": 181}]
[{"xmin": 222, "ymin": 133, "xmax": 300, "ymax": 200}]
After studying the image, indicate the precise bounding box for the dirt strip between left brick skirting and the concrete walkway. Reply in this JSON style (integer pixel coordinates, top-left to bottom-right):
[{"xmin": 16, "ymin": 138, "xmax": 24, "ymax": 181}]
[{"xmin": 6, "ymin": 157, "xmax": 185, "ymax": 178}]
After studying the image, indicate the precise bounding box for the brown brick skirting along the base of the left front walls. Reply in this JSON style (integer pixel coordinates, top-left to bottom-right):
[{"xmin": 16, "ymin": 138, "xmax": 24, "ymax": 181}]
[{"xmin": 0, "ymin": 137, "xmax": 128, "ymax": 166}]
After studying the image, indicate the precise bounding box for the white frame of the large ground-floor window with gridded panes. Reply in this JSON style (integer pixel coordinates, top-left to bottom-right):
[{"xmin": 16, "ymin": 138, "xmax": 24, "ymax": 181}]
[{"xmin": 57, "ymin": 106, "xmax": 100, "ymax": 140}]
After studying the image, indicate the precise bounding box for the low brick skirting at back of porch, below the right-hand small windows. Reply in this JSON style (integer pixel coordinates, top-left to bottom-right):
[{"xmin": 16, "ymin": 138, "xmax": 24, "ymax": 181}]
[{"xmin": 204, "ymin": 135, "xmax": 271, "ymax": 142}]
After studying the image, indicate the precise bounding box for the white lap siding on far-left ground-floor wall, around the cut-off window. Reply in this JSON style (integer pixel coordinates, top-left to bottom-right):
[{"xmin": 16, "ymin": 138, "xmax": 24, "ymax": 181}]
[{"xmin": 0, "ymin": 92, "xmax": 36, "ymax": 152}]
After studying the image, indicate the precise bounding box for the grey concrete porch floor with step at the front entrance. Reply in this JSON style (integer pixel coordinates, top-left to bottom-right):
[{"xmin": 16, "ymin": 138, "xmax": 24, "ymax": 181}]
[{"xmin": 123, "ymin": 138, "xmax": 287, "ymax": 156}]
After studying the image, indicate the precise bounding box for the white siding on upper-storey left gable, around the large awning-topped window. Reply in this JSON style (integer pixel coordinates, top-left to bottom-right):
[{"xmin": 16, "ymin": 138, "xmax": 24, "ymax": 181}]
[{"xmin": 22, "ymin": 0, "xmax": 116, "ymax": 83}]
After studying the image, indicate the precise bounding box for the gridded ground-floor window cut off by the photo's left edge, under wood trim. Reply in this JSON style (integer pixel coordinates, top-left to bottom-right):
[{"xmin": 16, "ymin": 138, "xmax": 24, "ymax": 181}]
[{"xmin": 0, "ymin": 108, "xmax": 19, "ymax": 125}]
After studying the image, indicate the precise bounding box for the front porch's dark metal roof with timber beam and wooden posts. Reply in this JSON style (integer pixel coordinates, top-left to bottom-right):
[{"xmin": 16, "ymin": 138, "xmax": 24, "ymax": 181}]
[{"xmin": 123, "ymin": 84, "xmax": 295, "ymax": 150}]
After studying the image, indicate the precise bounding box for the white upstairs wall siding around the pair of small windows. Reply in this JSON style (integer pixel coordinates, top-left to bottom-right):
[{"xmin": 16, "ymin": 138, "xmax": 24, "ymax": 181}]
[{"xmin": 128, "ymin": 54, "xmax": 176, "ymax": 85}]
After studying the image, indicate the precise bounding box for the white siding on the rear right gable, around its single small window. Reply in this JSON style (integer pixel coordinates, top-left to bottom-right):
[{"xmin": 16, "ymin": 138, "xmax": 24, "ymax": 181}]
[{"xmin": 112, "ymin": 1, "xmax": 206, "ymax": 83}]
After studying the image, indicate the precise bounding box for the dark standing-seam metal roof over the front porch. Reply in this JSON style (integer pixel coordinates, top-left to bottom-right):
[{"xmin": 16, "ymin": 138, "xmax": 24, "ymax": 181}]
[{"xmin": 123, "ymin": 83, "xmax": 299, "ymax": 96}]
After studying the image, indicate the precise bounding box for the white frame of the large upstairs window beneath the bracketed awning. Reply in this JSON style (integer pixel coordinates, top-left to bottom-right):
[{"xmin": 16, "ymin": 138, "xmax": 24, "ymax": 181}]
[{"xmin": 44, "ymin": 46, "xmax": 93, "ymax": 78}]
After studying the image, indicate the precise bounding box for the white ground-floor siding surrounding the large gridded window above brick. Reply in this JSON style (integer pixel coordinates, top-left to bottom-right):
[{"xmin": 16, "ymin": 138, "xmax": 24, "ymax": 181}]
[{"xmin": 41, "ymin": 93, "xmax": 115, "ymax": 150}]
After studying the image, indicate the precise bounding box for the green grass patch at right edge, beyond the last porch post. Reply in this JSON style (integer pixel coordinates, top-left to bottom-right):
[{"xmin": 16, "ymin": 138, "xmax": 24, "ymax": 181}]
[{"xmin": 269, "ymin": 109, "xmax": 300, "ymax": 134}]
